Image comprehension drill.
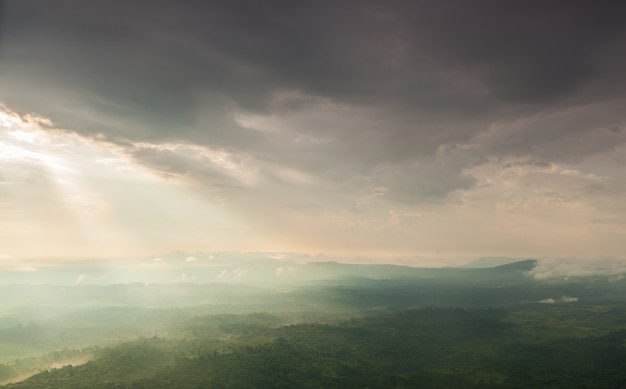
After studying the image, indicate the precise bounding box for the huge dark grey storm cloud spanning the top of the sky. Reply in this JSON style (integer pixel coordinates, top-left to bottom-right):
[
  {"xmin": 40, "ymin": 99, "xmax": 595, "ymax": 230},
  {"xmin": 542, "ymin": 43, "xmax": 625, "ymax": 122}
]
[{"xmin": 0, "ymin": 0, "xmax": 626, "ymax": 203}]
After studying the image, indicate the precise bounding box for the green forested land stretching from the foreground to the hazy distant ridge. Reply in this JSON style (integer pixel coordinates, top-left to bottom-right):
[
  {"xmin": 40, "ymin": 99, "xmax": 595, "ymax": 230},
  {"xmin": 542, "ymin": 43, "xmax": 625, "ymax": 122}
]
[{"xmin": 0, "ymin": 260, "xmax": 626, "ymax": 389}]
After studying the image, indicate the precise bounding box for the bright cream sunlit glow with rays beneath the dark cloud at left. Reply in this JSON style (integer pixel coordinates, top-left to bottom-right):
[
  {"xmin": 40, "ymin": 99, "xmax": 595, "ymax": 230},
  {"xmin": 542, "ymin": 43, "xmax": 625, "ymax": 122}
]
[{"xmin": 0, "ymin": 107, "xmax": 264, "ymax": 258}]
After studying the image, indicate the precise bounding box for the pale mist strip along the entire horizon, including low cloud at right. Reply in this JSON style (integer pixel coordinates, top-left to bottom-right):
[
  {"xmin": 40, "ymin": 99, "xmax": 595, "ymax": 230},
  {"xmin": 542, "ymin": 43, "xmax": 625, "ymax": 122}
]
[{"xmin": 0, "ymin": 252, "xmax": 626, "ymax": 286}]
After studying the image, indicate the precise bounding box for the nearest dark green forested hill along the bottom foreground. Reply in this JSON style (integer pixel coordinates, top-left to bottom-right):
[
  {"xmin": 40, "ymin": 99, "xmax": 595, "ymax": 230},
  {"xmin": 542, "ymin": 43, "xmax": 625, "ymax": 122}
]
[{"xmin": 7, "ymin": 308, "xmax": 626, "ymax": 389}]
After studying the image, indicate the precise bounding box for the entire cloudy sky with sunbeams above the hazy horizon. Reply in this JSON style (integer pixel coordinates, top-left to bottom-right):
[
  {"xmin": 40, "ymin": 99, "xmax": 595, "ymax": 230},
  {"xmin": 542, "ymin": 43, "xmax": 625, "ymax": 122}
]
[{"xmin": 0, "ymin": 0, "xmax": 626, "ymax": 264}]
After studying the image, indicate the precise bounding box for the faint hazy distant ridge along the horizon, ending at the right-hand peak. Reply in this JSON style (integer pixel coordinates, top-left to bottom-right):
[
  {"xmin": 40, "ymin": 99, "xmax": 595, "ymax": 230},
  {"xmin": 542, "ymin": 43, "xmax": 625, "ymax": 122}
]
[{"xmin": 0, "ymin": 258, "xmax": 537, "ymax": 285}]
